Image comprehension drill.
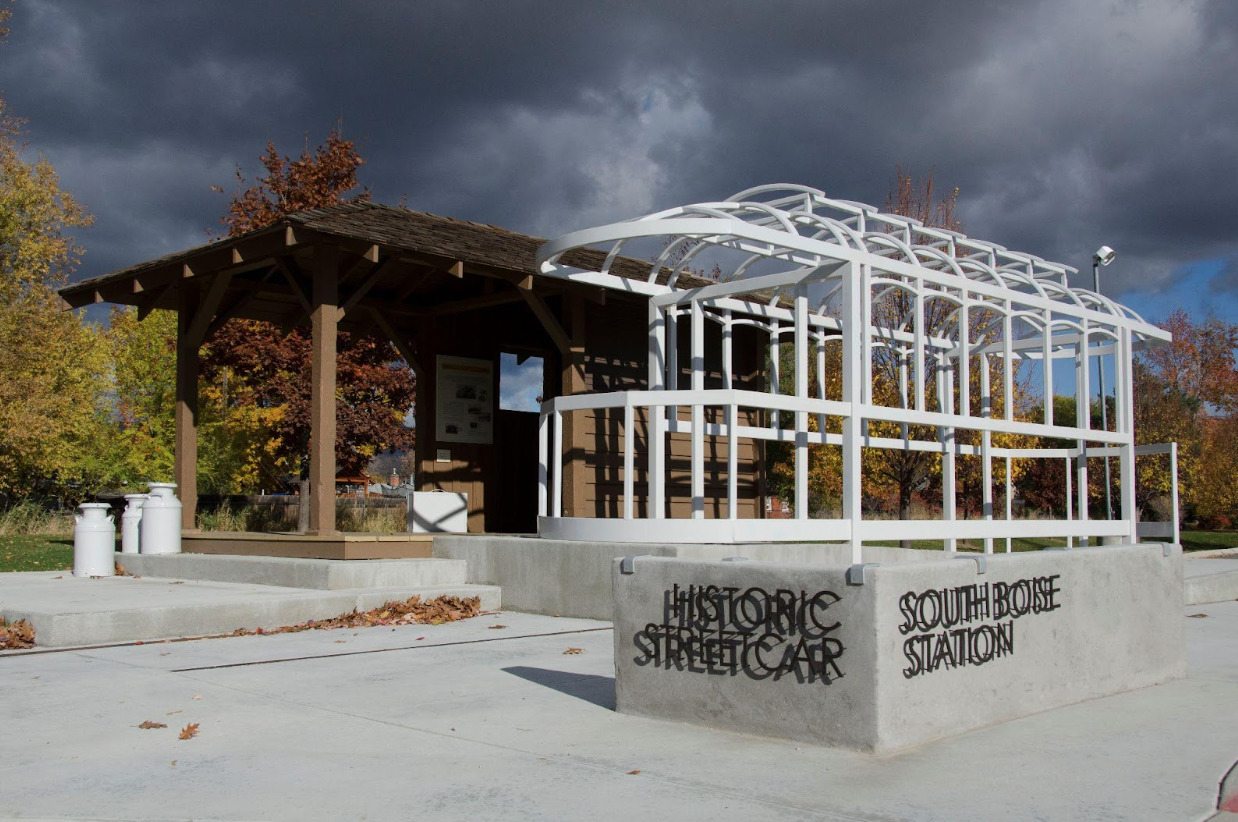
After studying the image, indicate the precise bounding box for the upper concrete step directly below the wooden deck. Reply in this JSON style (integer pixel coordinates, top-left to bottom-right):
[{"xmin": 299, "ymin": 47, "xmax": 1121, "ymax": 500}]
[{"xmin": 116, "ymin": 552, "xmax": 468, "ymax": 591}]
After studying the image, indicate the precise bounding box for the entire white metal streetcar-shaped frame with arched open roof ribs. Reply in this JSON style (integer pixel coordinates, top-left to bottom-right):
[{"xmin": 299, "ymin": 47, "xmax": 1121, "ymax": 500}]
[{"xmin": 537, "ymin": 184, "xmax": 1176, "ymax": 561}]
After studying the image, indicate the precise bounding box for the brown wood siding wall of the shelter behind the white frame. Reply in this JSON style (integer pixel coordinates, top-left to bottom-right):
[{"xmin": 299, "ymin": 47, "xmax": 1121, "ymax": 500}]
[{"xmin": 416, "ymin": 288, "xmax": 765, "ymax": 531}]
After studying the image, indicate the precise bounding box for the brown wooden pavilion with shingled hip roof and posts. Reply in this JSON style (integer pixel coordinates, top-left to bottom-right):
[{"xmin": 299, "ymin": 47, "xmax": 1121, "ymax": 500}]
[{"xmin": 61, "ymin": 203, "xmax": 765, "ymax": 558}]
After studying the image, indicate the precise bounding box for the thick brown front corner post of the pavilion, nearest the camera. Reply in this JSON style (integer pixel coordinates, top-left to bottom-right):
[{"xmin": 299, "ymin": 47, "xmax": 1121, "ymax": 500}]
[{"xmin": 308, "ymin": 245, "xmax": 339, "ymax": 534}]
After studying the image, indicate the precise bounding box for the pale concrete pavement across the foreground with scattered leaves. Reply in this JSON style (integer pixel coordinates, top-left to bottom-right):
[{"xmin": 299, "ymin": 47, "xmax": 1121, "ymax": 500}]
[{"xmin": 0, "ymin": 602, "xmax": 1238, "ymax": 822}]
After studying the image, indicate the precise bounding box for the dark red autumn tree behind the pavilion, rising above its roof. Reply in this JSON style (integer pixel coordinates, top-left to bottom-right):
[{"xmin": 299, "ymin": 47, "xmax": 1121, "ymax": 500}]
[{"xmin": 199, "ymin": 129, "xmax": 415, "ymax": 490}]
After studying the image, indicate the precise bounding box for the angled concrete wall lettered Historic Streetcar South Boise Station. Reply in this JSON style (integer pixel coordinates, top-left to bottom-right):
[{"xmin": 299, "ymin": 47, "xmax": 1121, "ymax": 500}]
[{"xmin": 613, "ymin": 545, "xmax": 1186, "ymax": 751}]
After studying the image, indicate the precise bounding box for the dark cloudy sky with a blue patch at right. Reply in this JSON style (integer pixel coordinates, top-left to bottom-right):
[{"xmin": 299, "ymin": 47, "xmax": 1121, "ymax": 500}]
[{"xmin": 0, "ymin": 0, "xmax": 1238, "ymax": 322}]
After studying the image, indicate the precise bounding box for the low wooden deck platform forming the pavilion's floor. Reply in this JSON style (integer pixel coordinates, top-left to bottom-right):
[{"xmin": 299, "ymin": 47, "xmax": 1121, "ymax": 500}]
[{"xmin": 181, "ymin": 531, "xmax": 435, "ymax": 560}]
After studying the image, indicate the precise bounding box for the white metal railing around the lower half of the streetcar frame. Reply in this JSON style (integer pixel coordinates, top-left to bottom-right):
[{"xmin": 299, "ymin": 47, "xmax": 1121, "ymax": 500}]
[{"xmin": 539, "ymin": 389, "xmax": 1158, "ymax": 553}]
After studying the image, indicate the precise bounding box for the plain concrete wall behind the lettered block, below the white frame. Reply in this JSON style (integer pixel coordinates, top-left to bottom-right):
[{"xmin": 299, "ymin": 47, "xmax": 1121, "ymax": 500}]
[{"xmin": 433, "ymin": 534, "xmax": 942, "ymax": 619}]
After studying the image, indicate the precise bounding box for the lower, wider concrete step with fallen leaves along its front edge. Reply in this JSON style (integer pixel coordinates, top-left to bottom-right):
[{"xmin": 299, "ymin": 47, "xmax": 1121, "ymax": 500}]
[{"xmin": 0, "ymin": 572, "xmax": 503, "ymax": 647}]
